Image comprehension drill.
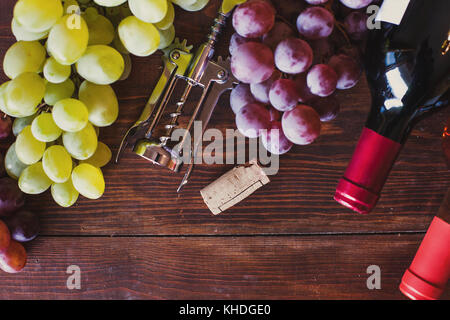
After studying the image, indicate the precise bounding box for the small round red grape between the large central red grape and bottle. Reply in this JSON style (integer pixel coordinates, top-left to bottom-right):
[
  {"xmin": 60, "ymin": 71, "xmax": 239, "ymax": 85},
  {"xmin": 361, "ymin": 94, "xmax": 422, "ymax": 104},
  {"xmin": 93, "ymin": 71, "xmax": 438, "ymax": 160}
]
[{"xmin": 306, "ymin": 64, "xmax": 338, "ymax": 97}]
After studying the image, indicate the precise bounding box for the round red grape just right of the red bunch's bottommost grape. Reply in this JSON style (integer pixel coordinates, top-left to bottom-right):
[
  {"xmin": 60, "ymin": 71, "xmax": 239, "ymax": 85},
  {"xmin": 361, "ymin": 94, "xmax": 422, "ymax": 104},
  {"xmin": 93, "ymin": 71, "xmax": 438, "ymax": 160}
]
[{"xmin": 281, "ymin": 104, "xmax": 321, "ymax": 145}]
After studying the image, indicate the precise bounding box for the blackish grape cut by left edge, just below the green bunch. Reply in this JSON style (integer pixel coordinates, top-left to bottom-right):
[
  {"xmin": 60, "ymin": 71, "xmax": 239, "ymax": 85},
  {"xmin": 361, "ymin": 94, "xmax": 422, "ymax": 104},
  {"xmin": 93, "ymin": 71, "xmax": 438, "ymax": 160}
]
[{"xmin": 0, "ymin": 177, "xmax": 24, "ymax": 217}]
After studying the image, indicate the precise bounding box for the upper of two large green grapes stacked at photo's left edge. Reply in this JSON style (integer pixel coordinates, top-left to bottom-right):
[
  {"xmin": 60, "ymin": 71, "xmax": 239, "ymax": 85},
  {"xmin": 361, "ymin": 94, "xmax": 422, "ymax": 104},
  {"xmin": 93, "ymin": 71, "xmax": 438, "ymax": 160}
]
[{"xmin": 3, "ymin": 41, "xmax": 46, "ymax": 79}]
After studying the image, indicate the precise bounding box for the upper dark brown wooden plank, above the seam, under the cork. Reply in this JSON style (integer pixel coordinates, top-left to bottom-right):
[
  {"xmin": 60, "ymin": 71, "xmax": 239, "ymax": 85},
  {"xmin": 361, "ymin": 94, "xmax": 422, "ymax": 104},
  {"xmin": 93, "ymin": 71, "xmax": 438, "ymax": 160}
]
[{"xmin": 0, "ymin": 0, "xmax": 450, "ymax": 235}]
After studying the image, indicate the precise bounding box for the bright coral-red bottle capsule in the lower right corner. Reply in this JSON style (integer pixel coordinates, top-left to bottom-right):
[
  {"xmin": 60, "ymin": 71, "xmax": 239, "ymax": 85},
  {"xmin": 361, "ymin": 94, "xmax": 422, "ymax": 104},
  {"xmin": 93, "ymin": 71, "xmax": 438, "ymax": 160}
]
[{"xmin": 400, "ymin": 217, "xmax": 450, "ymax": 300}]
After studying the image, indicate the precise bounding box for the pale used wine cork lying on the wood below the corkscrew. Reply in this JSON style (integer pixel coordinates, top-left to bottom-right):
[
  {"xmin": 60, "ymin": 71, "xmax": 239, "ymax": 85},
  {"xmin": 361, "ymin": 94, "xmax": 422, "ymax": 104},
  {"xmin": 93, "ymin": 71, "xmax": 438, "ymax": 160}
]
[{"xmin": 200, "ymin": 160, "xmax": 270, "ymax": 215}]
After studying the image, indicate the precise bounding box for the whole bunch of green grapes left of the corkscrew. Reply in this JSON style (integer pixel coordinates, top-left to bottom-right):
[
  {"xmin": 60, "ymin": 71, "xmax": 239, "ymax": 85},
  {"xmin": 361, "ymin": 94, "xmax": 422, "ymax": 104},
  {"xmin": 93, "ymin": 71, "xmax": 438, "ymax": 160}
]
[{"xmin": 0, "ymin": 0, "xmax": 208, "ymax": 207}]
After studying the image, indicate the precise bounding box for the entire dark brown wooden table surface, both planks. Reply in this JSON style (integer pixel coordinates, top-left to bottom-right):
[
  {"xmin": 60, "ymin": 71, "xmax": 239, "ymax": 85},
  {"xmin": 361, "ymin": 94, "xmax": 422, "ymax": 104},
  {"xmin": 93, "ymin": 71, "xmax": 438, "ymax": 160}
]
[{"xmin": 0, "ymin": 0, "xmax": 450, "ymax": 299}]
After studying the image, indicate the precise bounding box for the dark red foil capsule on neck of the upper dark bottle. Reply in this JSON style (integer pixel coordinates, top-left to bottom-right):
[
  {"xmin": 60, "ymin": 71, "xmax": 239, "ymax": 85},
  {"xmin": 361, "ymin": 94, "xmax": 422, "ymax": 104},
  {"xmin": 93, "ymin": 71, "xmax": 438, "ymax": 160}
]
[{"xmin": 334, "ymin": 128, "xmax": 401, "ymax": 213}]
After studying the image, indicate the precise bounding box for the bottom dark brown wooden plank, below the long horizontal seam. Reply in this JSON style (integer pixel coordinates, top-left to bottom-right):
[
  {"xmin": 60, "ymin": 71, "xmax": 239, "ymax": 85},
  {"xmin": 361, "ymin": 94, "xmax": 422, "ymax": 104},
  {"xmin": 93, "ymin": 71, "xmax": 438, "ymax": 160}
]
[{"xmin": 0, "ymin": 234, "xmax": 449, "ymax": 299}]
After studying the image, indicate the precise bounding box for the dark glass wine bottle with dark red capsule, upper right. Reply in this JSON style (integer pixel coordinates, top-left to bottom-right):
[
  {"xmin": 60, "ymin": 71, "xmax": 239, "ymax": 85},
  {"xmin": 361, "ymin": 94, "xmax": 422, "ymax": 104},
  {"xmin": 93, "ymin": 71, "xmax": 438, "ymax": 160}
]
[{"xmin": 334, "ymin": 0, "xmax": 450, "ymax": 213}]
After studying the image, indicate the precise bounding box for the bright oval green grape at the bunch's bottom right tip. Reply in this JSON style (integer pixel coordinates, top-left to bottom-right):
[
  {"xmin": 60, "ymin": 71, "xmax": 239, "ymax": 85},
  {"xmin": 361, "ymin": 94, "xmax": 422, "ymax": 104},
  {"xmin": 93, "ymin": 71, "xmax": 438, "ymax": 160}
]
[{"xmin": 72, "ymin": 163, "xmax": 105, "ymax": 199}]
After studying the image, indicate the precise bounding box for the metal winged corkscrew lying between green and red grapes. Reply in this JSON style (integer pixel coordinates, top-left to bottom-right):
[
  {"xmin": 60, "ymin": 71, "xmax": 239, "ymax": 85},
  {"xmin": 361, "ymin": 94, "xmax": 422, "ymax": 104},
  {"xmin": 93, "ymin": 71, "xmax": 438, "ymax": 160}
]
[{"xmin": 116, "ymin": 5, "xmax": 238, "ymax": 192}]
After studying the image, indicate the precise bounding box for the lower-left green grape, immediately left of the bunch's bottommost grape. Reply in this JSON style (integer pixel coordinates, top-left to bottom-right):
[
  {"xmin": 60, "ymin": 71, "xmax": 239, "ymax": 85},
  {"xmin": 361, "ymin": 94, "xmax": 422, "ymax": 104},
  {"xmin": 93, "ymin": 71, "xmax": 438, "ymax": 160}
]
[{"xmin": 19, "ymin": 161, "xmax": 52, "ymax": 194}]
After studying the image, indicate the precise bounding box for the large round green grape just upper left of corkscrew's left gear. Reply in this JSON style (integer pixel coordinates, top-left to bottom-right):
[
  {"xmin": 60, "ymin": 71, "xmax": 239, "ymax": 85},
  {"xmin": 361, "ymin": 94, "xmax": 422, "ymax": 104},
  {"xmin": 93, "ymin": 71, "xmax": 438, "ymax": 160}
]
[{"xmin": 117, "ymin": 16, "xmax": 160, "ymax": 57}]
